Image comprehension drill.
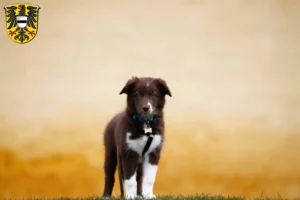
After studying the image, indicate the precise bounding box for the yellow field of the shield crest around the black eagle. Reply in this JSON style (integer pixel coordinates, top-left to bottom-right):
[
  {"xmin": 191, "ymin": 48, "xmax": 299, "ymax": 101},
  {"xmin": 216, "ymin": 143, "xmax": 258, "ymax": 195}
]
[{"xmin": 6, "ymin": 4, "xmax": 39, "ymax": 44}]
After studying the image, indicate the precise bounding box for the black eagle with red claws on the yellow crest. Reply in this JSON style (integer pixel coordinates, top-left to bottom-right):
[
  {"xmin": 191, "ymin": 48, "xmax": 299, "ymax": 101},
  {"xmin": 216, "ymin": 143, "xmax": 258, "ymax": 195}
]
[{"xmin": 6, "ymin": 4, "xmax": 39, "ymax": 43}]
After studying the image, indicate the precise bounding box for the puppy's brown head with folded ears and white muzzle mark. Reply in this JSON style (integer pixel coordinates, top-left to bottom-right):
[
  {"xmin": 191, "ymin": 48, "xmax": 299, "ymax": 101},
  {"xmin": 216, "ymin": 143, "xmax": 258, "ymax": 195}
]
[{"xmin": 120, "ymin": 77, "xmax": 172, "ymax": 119}]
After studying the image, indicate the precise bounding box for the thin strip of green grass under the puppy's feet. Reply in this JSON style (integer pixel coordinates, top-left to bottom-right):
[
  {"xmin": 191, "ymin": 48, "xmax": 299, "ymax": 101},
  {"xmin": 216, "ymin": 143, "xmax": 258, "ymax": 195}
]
[{"xmin": 21, "ymin": 195, "xmax": 292, "ymax": 200}]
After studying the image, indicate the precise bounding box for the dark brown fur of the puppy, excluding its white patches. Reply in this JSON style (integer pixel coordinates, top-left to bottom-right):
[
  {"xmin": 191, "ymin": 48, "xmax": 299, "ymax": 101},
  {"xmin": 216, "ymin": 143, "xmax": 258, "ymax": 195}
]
[{"xmin": 103, "ymin": 77, "xmax": 171, "ymax": 197}]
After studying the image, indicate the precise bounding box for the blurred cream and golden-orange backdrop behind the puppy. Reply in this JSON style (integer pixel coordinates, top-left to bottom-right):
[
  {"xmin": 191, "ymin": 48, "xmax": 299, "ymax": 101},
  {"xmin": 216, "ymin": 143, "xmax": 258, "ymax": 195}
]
[{"xmin": 0, "ymin": 0, "xmax": 300, "ymax": 198}]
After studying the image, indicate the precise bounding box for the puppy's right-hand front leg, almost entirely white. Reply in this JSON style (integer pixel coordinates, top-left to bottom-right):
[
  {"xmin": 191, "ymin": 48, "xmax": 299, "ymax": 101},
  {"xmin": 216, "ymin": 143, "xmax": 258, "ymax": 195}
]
[{"xmin": 142, "ymin": 153, "xmax": 159, "ymax": 199}]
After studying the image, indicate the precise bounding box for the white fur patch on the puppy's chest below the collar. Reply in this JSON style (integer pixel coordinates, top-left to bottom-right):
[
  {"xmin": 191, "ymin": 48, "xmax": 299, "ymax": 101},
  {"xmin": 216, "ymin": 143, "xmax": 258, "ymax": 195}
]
[{"xmin": 126, "ymin": 132, "xmax": 161, "ymax": 156}]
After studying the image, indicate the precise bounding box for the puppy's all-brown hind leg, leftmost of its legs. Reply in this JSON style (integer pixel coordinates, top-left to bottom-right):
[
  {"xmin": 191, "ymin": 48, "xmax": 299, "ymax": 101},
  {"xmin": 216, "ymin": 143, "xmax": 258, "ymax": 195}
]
[{"xmin": 103, "ymin": 149, "xmax": 117, "ymax": 197}]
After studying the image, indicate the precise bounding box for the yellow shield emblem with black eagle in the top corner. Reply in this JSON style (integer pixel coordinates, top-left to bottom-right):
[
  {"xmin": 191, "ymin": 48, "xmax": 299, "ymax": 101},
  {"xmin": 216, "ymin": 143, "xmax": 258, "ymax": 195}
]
[{"xmin": 4, "ymin": 4, "xmax": 40, "ymax": 44}]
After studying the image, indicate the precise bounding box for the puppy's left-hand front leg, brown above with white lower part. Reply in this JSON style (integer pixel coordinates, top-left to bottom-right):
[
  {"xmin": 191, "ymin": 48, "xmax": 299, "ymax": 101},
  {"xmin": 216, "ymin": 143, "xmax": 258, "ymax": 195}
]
[{"xmin": 122, "ymin": 155, "xmax": 138, "ymax": 199}]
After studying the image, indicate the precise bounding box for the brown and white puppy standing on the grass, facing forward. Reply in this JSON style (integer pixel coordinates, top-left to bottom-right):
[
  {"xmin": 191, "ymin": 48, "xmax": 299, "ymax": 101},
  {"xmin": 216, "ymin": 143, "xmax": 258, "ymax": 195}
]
[{"xmin": 103, "ymin": 77, "xmax": 172, "ymax": 199}]
